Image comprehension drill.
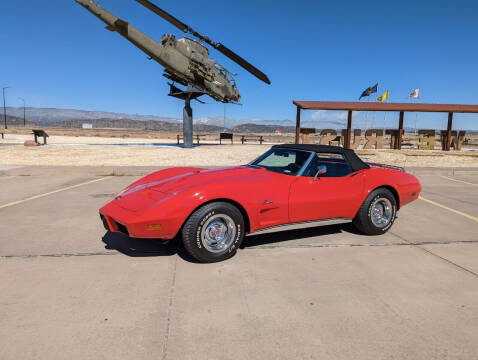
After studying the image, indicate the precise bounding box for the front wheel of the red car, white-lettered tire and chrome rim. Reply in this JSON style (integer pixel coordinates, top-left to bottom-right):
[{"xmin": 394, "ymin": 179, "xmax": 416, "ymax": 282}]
[{"xmin": 182, "ymin": 201, "xmax": 244, "ymax": 263}]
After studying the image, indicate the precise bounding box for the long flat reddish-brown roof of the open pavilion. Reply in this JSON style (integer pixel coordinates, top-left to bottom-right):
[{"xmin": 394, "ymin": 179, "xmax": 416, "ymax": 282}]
[{"xmin": 294, "ymin": 100, "xmax": 478, "ymax": 113}]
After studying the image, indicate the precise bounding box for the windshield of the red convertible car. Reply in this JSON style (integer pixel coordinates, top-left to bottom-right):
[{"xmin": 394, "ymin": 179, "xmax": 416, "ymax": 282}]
[{"xmin": 249, "ymin": 149, "xmax": 311, "ymax": 176}]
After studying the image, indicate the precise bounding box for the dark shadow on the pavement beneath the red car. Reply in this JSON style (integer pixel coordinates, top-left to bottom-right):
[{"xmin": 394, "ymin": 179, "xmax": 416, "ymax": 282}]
[{"xmin": 102, "ymin": 223, "xmax": 360, "ymax": 263}]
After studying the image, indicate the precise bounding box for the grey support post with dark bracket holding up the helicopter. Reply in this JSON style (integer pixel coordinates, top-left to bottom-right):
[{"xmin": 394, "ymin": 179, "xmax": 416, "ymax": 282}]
[{"xmin": 168, "ymin": 83, "xmax": 207, "ymax": 149}]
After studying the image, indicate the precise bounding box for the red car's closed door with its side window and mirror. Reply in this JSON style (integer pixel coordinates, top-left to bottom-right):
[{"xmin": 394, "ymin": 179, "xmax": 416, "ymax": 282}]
[{"xmin": 289, "ymin": 153, "xmax": 365, "ymax": 222}]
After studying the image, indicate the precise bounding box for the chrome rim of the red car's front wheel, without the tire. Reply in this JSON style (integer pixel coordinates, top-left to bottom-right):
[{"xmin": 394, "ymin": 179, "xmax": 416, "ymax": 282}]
[{"xmin": 201, "ymin": 214, "xmax": 236, "ymax": 253}]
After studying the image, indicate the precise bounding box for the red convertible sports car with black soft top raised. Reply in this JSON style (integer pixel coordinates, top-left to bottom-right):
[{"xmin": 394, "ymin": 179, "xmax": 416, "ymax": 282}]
[{"xmin": 100, "ymin": 144, "xmax": 421, "ymax": 262}]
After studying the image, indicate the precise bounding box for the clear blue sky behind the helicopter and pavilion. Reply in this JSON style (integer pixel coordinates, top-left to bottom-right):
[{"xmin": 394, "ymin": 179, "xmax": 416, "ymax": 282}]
[{"xmin": 0, "ymin": 0, "xmax": 478, "ymax": 129}]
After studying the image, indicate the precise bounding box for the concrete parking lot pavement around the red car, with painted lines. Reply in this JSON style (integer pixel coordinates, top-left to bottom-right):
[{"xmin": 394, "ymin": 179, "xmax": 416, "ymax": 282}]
[{"xmin": 0, "ymin": 167, "xmax": 478, "ymax": 360}]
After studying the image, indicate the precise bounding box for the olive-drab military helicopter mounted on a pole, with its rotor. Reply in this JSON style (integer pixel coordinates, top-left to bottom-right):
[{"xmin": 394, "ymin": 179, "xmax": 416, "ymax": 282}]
[{"xmin": 75, "ymin": 0, "xmax": 271, "ymax": 103}]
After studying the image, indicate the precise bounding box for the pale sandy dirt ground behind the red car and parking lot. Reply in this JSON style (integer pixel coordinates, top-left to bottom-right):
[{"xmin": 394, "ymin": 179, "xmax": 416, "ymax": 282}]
[{"xmin": 0, "ymin": 131, "xmax": 478, "ymax": 167}]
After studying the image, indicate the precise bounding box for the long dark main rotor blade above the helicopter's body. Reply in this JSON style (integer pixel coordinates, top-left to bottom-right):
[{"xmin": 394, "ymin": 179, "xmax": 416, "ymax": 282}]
[{"xmin": 136, "ymin": 0, "xmax": 271, "ymax": 85}]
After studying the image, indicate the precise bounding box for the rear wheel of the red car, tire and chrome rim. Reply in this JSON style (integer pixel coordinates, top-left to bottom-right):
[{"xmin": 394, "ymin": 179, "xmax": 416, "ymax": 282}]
[{"xmin": 353, "ymin": 188, "xmax": 397, "ymax": 235}]
